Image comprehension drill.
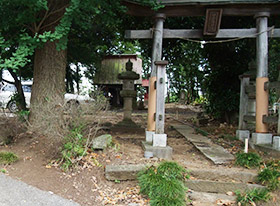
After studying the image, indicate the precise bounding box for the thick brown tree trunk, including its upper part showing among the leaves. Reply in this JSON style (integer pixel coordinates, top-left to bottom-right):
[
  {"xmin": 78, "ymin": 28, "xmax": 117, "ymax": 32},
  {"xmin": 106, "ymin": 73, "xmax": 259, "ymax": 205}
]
[{"xmin": 29, "ymin": 0, "xmax": 69, "ymax": 124}]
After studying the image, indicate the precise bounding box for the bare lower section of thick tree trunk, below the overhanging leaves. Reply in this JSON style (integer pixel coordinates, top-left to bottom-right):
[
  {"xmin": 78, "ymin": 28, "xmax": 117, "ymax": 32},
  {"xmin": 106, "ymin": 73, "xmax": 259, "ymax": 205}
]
[{"xmin": 30, "ymin": 42, "xmax": 67, "ymax": 123}]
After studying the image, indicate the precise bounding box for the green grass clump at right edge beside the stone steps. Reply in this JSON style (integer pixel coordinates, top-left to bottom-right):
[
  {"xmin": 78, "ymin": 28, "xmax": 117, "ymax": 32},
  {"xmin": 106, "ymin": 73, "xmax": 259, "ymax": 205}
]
[{"xmin": 258, "ymin": 160, "xmax": 280, "ymax": 190}]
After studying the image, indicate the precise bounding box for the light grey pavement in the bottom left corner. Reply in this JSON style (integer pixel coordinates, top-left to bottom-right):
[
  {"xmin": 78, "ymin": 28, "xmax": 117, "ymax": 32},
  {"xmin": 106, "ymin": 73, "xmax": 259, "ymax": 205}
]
[{"xmin": 0, "ymin": 174, "xmax": 79, "ymax": 206}]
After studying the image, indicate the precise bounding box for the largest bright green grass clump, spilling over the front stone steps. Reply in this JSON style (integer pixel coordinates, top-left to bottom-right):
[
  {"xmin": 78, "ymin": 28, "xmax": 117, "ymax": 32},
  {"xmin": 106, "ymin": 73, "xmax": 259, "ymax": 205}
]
[{"xmin": 138, "ymin": 162, "xmax": 187, "ymax": 206}]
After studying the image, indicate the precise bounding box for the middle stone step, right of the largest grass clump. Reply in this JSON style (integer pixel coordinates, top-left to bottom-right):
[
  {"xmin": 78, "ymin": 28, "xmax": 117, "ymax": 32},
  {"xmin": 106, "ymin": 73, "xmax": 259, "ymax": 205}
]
[{"xmin": 185, "ymin": 180, "xmax": 265, "ymax": 193}]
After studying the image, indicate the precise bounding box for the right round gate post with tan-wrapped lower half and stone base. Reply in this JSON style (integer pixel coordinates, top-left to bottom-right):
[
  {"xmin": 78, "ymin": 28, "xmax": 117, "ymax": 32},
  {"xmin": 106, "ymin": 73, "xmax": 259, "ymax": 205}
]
[{"xmin": 252, "ymin": 12, "xmax": 272, "ymax": 144}]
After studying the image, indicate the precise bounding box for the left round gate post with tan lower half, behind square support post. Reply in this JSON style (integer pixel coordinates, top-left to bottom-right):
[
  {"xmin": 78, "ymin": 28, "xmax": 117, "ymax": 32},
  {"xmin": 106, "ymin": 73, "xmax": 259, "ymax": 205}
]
[{"xmin": 146, "ymin": 13, "xmax": 165, "ymax": 142}]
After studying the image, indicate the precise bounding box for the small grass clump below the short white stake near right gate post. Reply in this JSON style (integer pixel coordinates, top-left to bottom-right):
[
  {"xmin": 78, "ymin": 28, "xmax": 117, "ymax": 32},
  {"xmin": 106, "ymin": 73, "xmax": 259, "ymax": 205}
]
[{"xmin": 235, "ymin": 152, "xmax": 262, "ymax": 168}]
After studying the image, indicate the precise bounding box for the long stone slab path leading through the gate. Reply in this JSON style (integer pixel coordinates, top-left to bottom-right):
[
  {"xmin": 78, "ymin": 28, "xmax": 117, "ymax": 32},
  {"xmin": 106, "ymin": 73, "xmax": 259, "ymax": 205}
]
[{"xmin": 171, "ymin": 124, "xmax": 234, "ymax": 164}]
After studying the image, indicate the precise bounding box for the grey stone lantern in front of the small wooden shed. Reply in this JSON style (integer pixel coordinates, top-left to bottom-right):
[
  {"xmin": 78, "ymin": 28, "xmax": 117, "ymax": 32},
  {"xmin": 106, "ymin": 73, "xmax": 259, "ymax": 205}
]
[{"xmin": 118, "ymin": 60, "xmax": 140, "ymax": 121}]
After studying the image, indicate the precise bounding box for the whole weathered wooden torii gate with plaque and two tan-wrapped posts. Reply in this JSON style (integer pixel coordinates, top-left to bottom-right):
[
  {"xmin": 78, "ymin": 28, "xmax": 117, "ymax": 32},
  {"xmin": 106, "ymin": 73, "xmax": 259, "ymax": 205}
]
[{"xmin": 124, "ymin": 0, "xmax": 280, "ymax": 151}]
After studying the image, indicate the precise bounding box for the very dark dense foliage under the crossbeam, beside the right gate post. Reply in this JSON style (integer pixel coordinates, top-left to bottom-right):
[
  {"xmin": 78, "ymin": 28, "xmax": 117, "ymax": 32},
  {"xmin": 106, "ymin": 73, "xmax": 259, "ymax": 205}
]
[{"xmin": 205, "ymin": 40, "xmax": 255, "ymax": 122}]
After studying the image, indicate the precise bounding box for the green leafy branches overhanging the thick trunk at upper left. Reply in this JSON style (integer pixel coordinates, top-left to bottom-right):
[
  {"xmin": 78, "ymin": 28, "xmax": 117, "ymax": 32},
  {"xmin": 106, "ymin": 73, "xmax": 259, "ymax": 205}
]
[{"xmin": 0, "ymin": 0, "xmax": 80, "ymax": 70}]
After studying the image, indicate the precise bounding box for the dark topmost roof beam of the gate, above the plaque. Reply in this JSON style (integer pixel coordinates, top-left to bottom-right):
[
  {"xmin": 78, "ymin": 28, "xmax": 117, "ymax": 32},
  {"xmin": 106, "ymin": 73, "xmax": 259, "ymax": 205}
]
[{"xmin": 123, "ymin": 0, "xmax": 280, "ymax": 17}]
